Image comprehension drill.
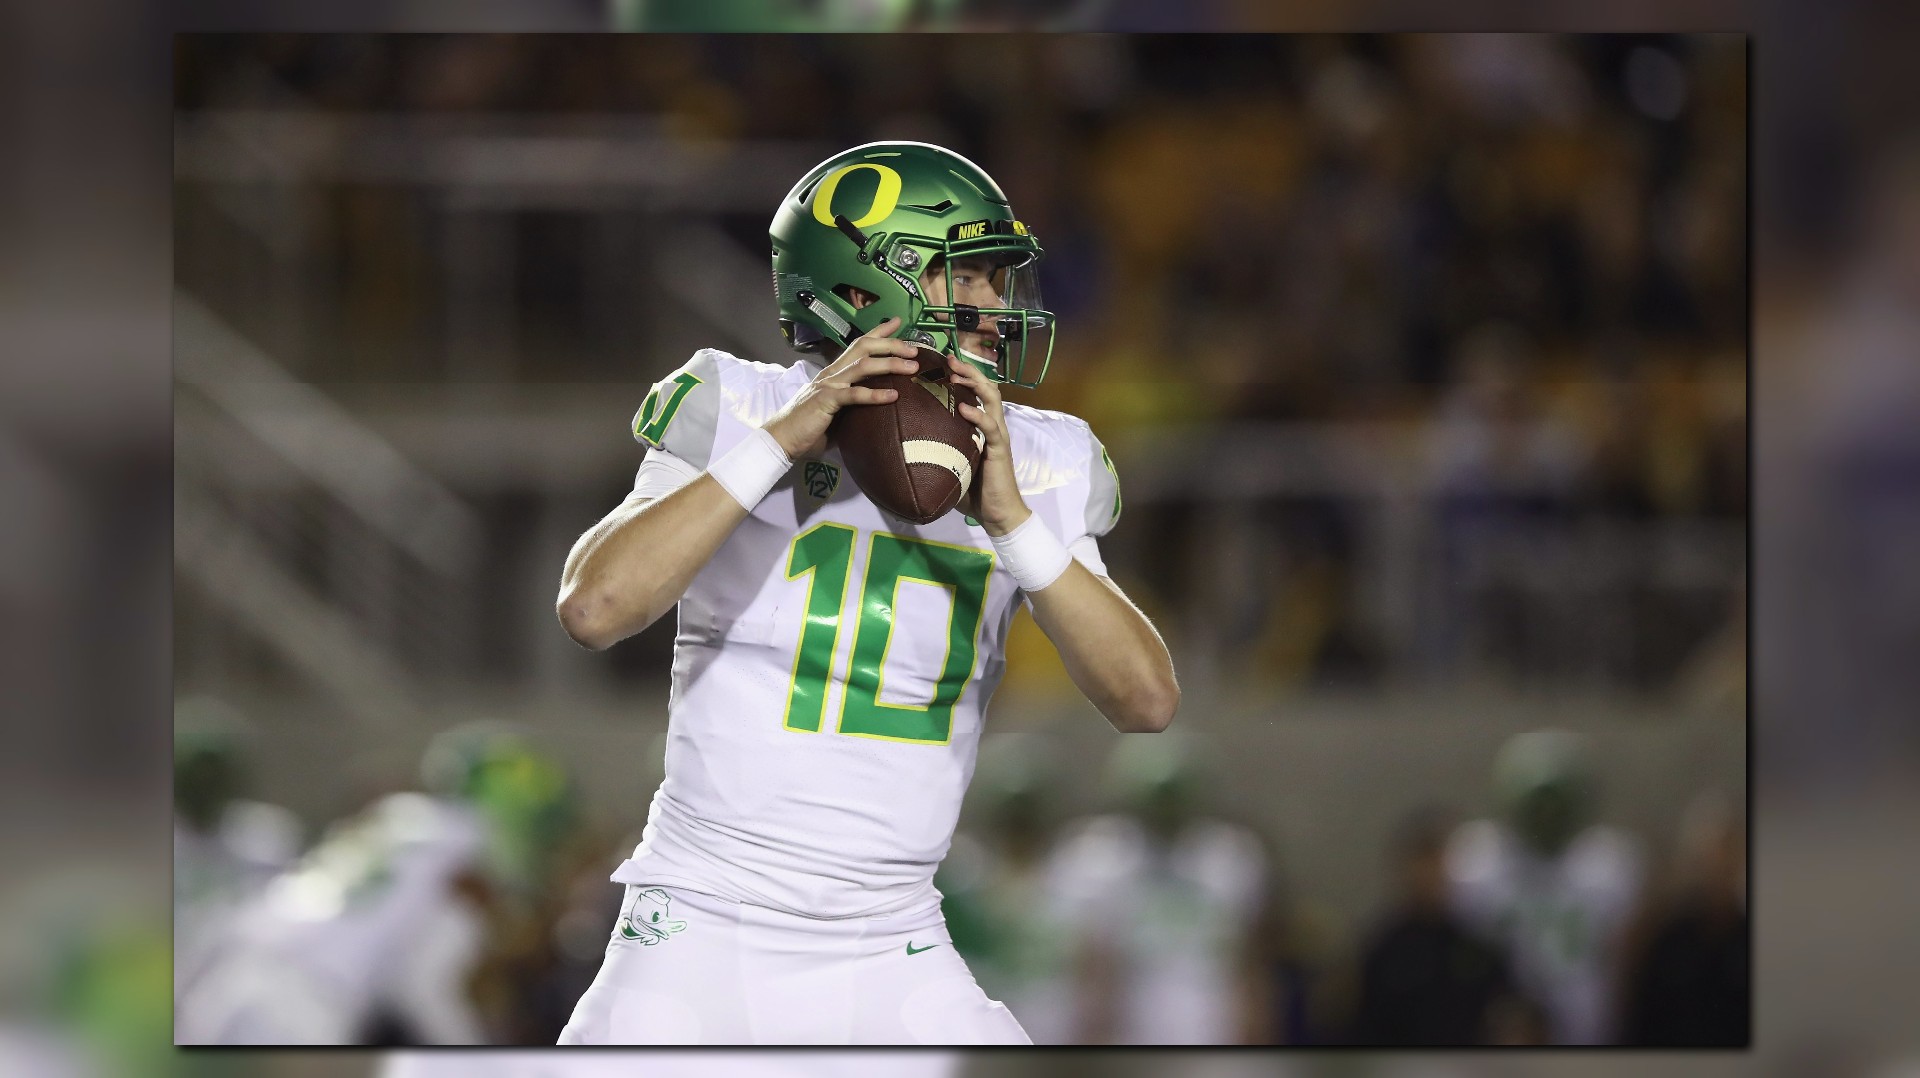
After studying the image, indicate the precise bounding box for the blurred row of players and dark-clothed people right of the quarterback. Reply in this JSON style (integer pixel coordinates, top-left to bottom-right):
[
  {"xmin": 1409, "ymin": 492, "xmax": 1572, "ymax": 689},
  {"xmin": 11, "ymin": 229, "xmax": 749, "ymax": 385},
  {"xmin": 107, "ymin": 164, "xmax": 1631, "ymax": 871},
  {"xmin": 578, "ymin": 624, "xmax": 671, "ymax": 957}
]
[{"xmin": 941, "ymin": 730, "xmax": 1749, "ymax": 1047}]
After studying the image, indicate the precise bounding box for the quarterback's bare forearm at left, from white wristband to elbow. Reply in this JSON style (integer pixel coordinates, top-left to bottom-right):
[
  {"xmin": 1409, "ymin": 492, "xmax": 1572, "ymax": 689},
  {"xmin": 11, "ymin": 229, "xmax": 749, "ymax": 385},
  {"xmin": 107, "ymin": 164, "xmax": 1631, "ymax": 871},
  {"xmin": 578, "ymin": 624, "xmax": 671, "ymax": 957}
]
[{"xmin": 555, "ymin": 475, "xmax": 747, "ymax": 651}]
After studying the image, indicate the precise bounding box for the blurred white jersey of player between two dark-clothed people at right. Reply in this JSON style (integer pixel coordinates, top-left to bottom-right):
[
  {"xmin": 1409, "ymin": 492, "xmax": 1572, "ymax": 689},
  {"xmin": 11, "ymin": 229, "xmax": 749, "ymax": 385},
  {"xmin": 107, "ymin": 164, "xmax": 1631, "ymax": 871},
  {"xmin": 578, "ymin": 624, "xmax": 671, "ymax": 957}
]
[{"xmin": 1448, "ymin": 821, "xmax": 1644, "ymax": 1045}]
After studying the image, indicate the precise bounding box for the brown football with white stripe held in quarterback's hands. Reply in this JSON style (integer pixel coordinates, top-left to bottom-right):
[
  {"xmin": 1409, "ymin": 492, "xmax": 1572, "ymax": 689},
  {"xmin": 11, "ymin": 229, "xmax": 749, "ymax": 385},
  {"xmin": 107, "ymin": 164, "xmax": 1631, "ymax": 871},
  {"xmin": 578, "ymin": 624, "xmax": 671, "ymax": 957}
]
[{"xmin": 828, "ymin": 348, "xmax": 985, "ymax": 525}]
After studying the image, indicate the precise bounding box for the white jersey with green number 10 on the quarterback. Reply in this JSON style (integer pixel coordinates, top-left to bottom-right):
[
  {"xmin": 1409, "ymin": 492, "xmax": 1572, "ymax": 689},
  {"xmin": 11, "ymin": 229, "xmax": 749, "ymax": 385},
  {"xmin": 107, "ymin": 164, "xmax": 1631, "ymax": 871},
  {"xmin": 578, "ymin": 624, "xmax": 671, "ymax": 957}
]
[{"xmin": 612, "ymin": 350, "xmax": 1119, "ymax": 917}]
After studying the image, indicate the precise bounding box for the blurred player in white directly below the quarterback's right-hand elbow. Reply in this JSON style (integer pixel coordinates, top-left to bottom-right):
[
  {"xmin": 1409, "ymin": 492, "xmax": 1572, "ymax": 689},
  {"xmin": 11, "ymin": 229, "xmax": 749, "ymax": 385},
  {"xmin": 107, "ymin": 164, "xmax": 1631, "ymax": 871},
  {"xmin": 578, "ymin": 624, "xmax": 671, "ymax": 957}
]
[{"xmin": 1054, "ymin": 738, "xmax": 1269, "ymax": 1043}]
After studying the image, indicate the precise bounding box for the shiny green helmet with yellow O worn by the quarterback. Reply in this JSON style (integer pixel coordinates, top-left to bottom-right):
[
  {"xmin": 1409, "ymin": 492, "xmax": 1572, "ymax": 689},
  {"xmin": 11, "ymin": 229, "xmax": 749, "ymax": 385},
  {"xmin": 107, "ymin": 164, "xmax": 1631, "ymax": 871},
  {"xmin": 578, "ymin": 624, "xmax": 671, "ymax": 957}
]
[{"xmin": 768, "ymin": 142, "xmax": 1054, "ymax": 388}]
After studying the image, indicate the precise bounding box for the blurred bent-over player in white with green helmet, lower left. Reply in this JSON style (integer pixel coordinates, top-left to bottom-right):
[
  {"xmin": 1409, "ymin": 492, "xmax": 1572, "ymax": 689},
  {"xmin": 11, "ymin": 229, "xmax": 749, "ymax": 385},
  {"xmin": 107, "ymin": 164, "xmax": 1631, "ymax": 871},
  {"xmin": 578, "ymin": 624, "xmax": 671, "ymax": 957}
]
[{"xmin": 177, "ymin": 726, "xmax": 568, "ymax": 1045}]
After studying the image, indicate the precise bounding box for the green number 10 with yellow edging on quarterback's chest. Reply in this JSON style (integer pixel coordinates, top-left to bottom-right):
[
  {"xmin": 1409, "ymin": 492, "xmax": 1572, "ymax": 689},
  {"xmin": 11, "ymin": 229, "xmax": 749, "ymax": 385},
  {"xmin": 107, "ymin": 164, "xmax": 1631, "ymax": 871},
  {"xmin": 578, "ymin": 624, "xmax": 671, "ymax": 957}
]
[{"xmin": 785, "ymin": 523, "xmax": 993, "ymax": 746}]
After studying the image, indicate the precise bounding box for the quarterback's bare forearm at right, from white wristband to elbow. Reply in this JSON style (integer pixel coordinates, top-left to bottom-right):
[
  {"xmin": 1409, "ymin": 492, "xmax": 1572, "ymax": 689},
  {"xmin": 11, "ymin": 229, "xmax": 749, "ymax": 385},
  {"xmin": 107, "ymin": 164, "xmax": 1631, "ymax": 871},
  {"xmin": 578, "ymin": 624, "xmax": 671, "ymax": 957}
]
[{"xmin": 1033, "ymin": 561, "xmax": 1181, "ymax": 734}]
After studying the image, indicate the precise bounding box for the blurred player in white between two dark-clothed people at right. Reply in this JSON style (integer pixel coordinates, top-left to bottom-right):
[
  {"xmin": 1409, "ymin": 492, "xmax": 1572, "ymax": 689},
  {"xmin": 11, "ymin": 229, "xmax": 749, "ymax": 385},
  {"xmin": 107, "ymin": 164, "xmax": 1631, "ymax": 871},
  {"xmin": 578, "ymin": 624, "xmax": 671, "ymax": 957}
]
[{"xmin": 1448, "ymin": 730, "xmax": 1644, "ymax": 1045}]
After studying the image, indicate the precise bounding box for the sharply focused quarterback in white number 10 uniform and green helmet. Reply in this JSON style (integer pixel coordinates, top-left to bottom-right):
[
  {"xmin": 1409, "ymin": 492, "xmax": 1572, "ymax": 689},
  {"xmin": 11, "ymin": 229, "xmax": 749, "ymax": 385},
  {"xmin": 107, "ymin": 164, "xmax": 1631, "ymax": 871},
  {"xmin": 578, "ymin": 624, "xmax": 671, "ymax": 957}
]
[{"xmin": 559, "ymin": 142, "xmax": 1179, "ymax": 1043}]
